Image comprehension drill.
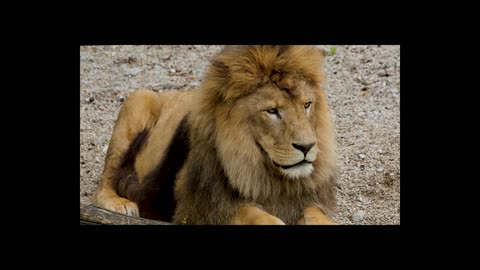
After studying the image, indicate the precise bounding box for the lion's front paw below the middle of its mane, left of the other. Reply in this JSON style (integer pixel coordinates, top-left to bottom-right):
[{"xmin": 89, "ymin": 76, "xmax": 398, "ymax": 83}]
[{"xmin": 232, "ymin": 206, "xmax": 285, "ymax": 225}]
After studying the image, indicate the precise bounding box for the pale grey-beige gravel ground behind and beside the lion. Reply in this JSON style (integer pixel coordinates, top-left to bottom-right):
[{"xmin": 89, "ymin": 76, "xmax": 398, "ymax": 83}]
[{"xmin": 80, "ymin": 45, "xmax": 400, "ymax": 225}]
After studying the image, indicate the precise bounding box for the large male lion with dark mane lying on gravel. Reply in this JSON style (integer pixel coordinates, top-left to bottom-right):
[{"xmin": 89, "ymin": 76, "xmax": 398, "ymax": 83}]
[{"xmin": 94, "ymin": 45, "xmax": 336, "ymax": 225}]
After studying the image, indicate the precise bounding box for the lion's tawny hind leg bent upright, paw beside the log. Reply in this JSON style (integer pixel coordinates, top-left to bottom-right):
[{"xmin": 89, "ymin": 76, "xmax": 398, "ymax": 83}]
[{"xmin": 93, "ymin": 90, "xmax": 162, "ymax": 216}]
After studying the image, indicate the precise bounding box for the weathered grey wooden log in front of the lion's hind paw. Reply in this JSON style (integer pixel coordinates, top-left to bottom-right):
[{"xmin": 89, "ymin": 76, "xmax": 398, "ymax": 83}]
[{"xmin": 80, "ymin": 204, "xmax": 173, "ymax": 225}]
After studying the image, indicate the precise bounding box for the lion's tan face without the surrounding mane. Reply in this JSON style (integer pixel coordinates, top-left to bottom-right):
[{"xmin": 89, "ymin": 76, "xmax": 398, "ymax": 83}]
[{"xmin": 239, "ymin": 80, "xmax": 318, "ymax": 178}]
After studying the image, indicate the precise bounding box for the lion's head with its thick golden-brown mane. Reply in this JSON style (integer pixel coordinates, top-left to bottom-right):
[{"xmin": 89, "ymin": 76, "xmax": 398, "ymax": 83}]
[{"xmin": 189, "ymin": 46, "xmax": 335, "ymax": 198}]
